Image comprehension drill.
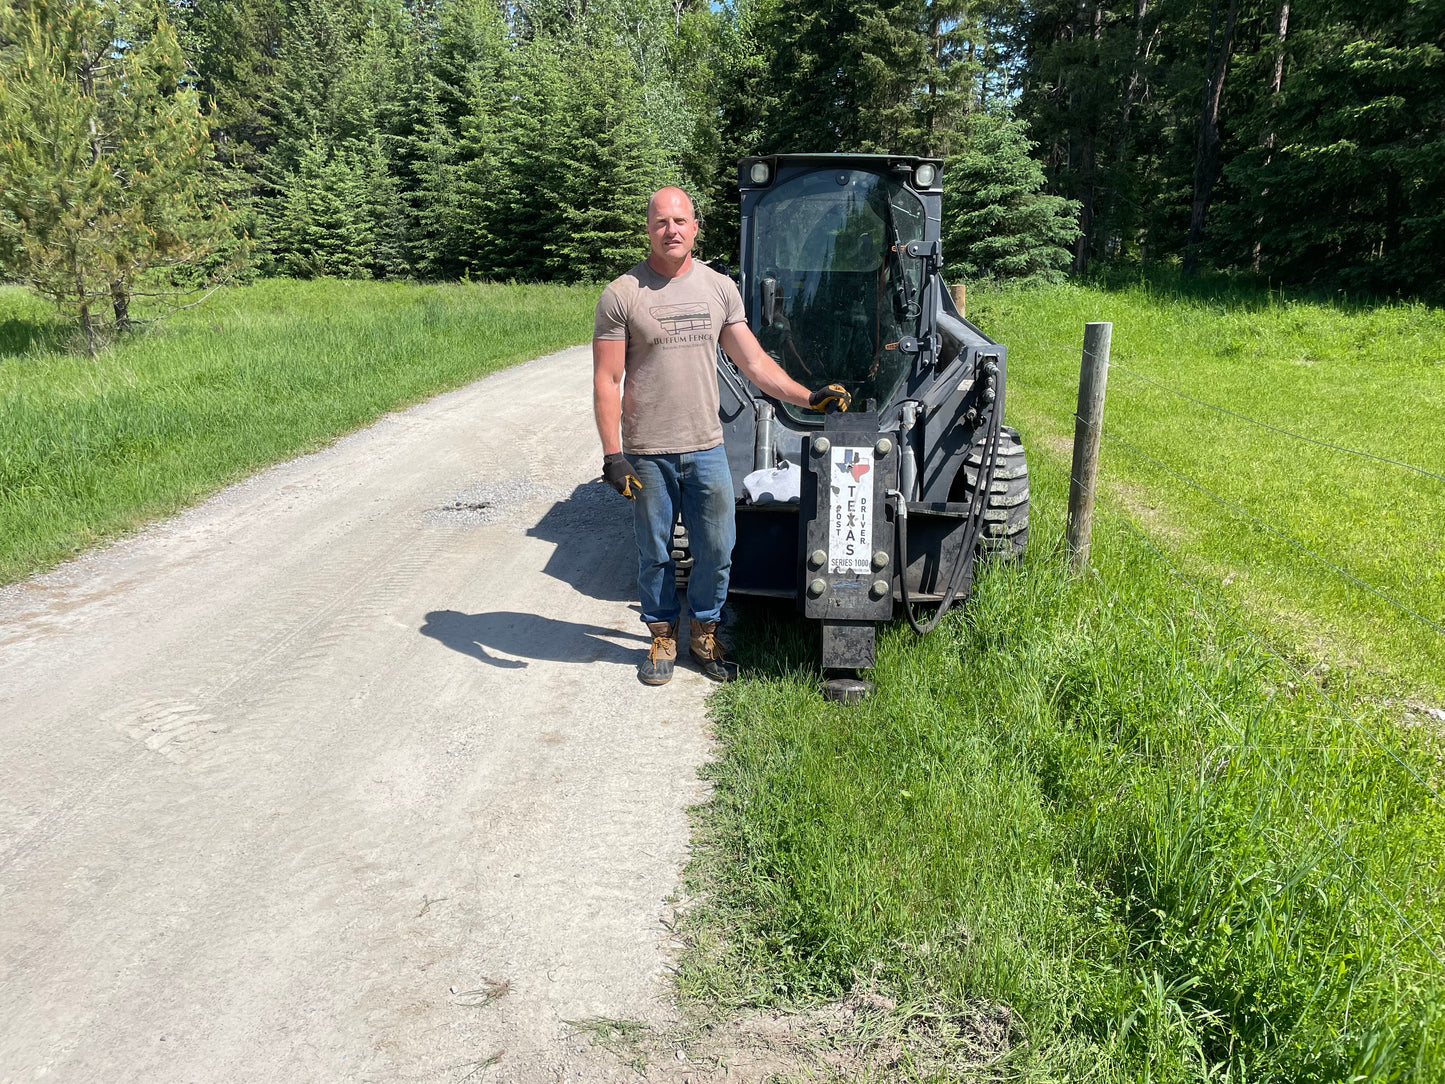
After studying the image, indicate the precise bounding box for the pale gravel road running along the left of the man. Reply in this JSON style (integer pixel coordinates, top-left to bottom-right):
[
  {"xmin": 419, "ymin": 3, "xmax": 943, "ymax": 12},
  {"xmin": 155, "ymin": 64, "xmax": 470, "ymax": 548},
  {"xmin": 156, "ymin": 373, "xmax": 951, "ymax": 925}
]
[{"xmin": 0, "ymin": 350, "xmax": 711, "ymax": 1084}]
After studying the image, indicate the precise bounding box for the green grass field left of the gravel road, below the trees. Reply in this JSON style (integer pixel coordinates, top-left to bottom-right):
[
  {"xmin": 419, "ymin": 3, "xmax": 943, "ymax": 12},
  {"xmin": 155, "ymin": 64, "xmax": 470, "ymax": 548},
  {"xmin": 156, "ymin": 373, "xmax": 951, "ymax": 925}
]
[{"xmin": 0, "ymin": 279, "xmax": 597, "ymax": 582}]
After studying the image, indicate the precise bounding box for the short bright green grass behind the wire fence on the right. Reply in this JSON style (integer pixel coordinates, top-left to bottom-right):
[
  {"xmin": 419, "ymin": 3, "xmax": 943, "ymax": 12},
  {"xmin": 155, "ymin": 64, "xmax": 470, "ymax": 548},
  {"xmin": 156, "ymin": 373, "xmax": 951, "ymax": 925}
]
[{"xmin": 970, "ymin": 283, "xmax": 1445, "ymax": 704}]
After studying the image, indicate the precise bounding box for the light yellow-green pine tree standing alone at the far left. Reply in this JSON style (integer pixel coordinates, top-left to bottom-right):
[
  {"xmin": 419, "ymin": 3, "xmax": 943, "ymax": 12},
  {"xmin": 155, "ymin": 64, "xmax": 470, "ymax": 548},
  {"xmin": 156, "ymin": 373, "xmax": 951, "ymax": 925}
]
[{"xmin": 0, "ymin": 0, "xmax": 244, "ymax": 354}]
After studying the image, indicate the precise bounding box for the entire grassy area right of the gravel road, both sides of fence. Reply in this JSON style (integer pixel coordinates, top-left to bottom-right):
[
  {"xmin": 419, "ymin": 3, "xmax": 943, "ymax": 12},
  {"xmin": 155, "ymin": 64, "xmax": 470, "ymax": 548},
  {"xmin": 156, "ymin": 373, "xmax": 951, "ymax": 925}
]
[{"xmin": 681, "ymin": 286, "xmax": 1445, "ymax": 1083}]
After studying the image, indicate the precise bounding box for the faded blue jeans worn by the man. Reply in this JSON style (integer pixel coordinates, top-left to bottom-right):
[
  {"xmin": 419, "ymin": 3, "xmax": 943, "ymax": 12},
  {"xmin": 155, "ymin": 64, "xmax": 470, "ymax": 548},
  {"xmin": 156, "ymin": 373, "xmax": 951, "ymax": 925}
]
[{"xmin": 627, "ymin": 444, "xmax": 736, "ymax": 623}]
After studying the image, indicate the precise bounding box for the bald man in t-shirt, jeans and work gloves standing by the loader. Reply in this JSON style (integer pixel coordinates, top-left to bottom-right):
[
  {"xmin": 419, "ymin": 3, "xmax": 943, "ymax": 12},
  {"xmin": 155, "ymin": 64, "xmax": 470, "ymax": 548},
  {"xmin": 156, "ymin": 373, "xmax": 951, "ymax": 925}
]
[{"xmin": 592, "ymin": 188, "xmax": 850, "ymax": 685}]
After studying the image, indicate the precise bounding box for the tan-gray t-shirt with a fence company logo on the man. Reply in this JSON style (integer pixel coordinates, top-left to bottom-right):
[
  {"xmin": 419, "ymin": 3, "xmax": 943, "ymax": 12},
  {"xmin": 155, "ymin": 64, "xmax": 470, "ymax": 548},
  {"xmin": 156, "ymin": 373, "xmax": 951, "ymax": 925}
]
[{"xmin": 592, "ymin": 260, "xmax": 747, "ymax": 455}]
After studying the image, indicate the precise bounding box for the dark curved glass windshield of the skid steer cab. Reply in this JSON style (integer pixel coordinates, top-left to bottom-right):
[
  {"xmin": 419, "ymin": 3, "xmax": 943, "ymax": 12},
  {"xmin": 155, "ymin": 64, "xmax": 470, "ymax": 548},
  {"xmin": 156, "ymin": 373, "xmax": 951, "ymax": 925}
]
[{"xmin": 750, "ymin": 169, "xmax": 923, "ymax": 421}]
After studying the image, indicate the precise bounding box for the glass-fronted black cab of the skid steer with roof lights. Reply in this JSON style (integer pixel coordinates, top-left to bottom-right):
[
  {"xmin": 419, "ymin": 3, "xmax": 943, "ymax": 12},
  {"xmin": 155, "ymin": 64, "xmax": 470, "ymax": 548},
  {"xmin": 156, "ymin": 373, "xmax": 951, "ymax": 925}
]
[{"xmin": 738, "ymin": 155, "xmax": 942, "ymax": 428}]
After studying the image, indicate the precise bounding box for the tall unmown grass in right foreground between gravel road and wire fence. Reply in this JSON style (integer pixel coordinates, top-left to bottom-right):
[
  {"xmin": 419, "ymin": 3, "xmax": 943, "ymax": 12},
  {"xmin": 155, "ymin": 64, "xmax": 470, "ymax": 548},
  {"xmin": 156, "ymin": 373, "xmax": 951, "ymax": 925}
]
[{"xmin": 682, "ymin": 465, "xmax": 1445, "ymax": 1081}]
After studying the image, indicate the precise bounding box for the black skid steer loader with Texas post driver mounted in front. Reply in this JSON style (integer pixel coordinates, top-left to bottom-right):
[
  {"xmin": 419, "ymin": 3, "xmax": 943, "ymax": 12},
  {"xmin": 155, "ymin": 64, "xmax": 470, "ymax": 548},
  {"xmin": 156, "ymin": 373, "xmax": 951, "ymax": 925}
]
[{"xmin": 673, "ymin": 155, "xmax": 1029, "ymax": 701}]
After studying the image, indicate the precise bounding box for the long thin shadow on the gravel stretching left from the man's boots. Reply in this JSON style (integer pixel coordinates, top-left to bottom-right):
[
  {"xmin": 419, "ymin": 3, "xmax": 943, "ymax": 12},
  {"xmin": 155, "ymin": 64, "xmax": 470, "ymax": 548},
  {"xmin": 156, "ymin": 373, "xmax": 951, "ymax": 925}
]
[{"xmin": 420, "ymin": 610, "xmax": 650, "ymax": 669}]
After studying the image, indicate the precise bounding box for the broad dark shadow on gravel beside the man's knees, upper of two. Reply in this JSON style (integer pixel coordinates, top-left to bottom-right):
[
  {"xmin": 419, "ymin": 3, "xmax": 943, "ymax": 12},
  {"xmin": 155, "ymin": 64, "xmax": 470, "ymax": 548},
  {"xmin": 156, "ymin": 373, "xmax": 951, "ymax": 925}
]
[{"xmin": 527, "ymin": 481, "xmax": 637, "ymax": 603}]
